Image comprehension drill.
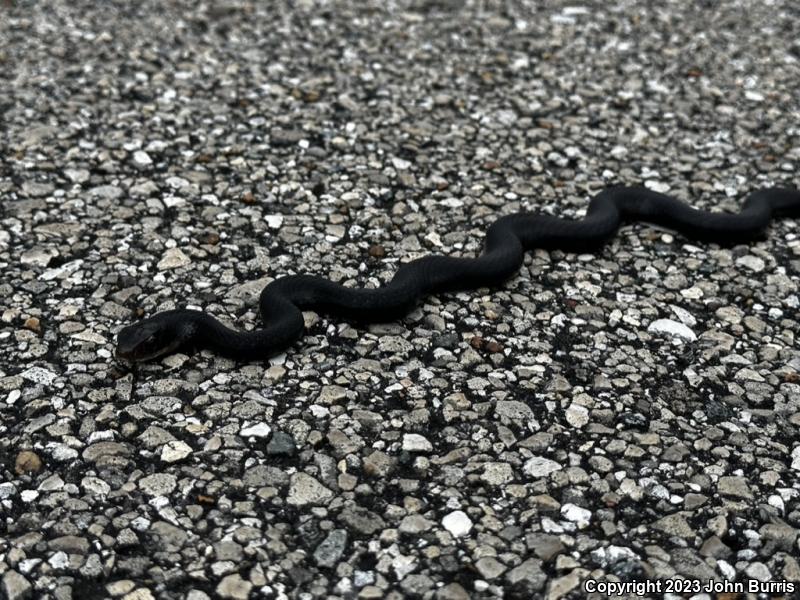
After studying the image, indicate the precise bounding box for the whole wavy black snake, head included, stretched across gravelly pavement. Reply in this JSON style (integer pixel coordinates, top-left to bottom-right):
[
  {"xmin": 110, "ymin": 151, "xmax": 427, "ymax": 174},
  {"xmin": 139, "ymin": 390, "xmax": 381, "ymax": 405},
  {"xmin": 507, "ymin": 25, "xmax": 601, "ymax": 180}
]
[{"xmin": 117, "ymin": 187, "xmax": 800, "ymax": 362}]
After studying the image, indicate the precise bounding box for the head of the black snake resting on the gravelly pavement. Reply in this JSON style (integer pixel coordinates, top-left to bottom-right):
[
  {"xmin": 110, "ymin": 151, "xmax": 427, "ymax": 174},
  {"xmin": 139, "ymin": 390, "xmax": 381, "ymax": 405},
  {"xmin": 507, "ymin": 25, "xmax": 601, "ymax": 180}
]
[{"xmin": 116, "ymin": 313, "xmax": 191, "ymax": 362}]
